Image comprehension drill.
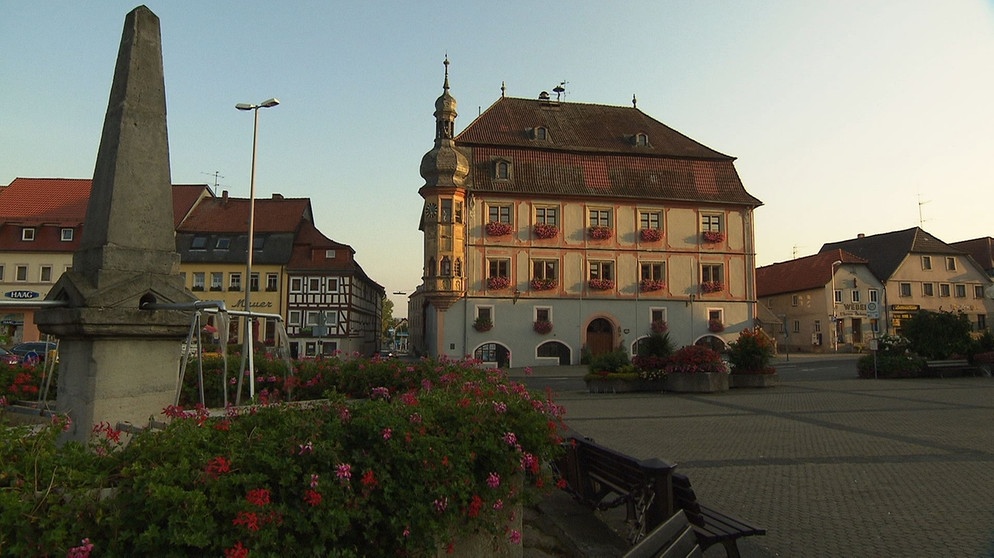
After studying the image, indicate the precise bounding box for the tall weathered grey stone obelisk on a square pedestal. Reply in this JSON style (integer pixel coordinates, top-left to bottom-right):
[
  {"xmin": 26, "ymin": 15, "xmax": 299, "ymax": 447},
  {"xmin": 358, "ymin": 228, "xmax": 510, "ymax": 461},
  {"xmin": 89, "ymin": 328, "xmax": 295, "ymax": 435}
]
[{"xmin": 36, "ymin": 6, "xmax": 196, "ymax": 440}]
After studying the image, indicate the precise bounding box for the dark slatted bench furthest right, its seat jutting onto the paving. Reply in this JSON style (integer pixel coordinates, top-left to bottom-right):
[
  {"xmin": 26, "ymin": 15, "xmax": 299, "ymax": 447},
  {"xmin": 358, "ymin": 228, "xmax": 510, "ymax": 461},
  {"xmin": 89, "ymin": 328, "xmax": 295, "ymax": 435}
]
[{"xmin": 671, "ymin": 473, "xmax": 766, "ymax": 558}]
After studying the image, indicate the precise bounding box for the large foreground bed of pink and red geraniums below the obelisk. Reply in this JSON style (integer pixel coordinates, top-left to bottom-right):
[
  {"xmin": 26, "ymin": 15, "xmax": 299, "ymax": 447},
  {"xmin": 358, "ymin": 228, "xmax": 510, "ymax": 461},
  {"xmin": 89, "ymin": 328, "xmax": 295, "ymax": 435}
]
[{"xmin": 0, "ymin": 359, "xmax": 562, "ymax": 556}]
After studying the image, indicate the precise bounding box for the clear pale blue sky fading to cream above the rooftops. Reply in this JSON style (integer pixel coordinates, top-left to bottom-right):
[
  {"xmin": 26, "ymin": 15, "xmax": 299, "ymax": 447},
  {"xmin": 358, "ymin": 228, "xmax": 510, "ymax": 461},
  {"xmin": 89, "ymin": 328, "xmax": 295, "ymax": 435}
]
[{"xmin": 0, "ymin": 0, "xmax": 994, "ymax": 317}]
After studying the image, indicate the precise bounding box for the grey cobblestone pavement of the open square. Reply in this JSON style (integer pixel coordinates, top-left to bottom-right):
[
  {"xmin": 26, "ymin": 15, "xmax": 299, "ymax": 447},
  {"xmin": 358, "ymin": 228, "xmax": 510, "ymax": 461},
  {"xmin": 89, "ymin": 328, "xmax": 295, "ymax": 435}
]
[{"xmin": 512, "ymin": 357, "xmax": 994, "ymax": 557}]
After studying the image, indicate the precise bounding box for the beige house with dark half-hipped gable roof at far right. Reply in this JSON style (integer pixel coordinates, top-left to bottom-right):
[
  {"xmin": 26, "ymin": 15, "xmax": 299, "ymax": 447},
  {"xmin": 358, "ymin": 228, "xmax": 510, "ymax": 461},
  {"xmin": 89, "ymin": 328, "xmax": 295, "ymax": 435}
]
[{"xmin": 821, "ymin": 227, "xmax": 994, "ymax": 334}]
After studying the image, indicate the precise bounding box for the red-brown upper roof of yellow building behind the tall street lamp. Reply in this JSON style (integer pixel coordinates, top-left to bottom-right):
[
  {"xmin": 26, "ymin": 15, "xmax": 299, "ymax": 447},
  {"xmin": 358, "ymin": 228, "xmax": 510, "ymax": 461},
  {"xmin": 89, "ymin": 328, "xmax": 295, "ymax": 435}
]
[{"xmin": 176, "ymin": 196, "xmax": 312, "ymax": 233}]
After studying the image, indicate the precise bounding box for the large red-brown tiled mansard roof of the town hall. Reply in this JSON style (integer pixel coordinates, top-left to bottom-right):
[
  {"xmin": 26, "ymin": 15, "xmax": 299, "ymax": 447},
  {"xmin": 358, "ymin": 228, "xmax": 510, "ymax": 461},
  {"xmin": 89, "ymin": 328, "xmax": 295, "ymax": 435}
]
[{"xmin": 456, "ymin": 98, "xmax": 762, "ymax": 207}]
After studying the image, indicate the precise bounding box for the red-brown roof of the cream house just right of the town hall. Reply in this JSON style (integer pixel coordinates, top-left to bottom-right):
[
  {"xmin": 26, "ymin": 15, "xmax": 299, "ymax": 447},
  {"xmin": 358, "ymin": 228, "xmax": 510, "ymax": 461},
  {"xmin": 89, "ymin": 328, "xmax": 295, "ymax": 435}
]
[{"xmin": 756, "ymin": 250, "xmax": 868, "ymax": 297}]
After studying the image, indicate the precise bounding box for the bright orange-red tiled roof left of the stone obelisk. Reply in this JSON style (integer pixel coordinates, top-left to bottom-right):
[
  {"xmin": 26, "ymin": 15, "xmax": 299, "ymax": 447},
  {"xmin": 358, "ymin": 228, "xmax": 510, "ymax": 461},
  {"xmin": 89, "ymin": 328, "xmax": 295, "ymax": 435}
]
[{"xmin": 0, "ymin": 178, "xmax": 92, "ymax": 227}]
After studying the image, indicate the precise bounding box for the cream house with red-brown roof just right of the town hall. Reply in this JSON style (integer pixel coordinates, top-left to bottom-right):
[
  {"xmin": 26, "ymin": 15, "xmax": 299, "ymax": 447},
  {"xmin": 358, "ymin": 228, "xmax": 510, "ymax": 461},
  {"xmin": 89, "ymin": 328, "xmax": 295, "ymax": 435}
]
[{"xmin": 756, "ymin": 250, "xmax": 886, "ymax": 352}]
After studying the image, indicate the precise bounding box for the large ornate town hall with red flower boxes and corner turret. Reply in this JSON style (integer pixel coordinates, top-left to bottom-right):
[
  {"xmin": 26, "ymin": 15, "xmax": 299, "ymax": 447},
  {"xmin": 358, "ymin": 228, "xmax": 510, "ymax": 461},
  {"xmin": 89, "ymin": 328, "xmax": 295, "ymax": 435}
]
[{"xmin": 408, "ymin": 61, "xmax": 761, "ymax": 366}]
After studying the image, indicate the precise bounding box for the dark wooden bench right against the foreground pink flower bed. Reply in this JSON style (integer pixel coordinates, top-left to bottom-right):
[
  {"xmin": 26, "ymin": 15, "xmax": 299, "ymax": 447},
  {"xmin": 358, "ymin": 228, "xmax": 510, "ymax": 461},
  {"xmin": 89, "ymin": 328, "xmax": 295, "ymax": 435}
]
[{"xmin": 553, "ymin": 434, "xmax": 675, "ymax": 544}]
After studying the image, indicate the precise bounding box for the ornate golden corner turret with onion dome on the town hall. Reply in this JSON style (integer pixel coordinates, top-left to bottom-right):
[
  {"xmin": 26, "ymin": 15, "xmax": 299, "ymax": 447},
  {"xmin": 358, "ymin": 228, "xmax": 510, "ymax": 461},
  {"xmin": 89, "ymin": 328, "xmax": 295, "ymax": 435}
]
[{"xmin": 418, "ymin": 57, "xmax": 469, "ymax": 312}]
